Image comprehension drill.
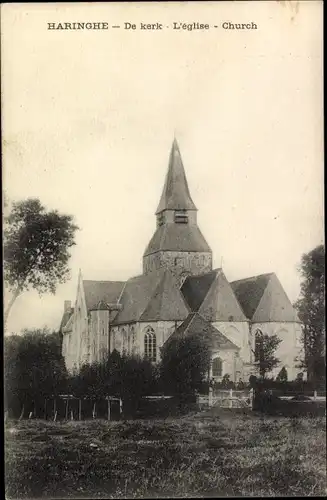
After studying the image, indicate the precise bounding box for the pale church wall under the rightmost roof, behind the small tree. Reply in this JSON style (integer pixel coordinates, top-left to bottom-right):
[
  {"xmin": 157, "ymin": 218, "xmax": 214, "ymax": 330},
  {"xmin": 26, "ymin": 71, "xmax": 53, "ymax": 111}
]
[{"xmin": 252, "ymin": 322, "xmax": 302, "ymax": 380}]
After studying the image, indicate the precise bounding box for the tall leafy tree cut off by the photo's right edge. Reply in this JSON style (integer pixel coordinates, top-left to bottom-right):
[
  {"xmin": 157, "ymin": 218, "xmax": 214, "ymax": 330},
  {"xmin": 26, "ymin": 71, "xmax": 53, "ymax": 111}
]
[{"xmin": 295, "ymin": 245, "xmax": 326, "ymax": 382}]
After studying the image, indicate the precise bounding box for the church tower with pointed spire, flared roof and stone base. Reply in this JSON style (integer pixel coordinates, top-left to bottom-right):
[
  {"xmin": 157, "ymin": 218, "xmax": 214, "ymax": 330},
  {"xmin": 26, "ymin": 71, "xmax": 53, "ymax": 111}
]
[{"xmin": 143, "ymin": 139, "xmax": 212, "ymax": 283}]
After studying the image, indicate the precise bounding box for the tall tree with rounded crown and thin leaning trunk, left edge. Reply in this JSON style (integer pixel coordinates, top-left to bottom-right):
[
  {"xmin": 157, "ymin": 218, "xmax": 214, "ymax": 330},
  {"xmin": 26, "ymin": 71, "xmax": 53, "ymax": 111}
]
[{"xmin": 3, "ymin": 198, "xmax": 78, "ymax": 324}]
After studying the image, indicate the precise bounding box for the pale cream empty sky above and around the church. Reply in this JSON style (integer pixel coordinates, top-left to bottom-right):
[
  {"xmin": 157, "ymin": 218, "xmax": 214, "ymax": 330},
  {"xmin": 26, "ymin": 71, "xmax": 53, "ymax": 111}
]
[{"xmin": 1, "ymin": 1, "xmax": 323, "ymax": 333}]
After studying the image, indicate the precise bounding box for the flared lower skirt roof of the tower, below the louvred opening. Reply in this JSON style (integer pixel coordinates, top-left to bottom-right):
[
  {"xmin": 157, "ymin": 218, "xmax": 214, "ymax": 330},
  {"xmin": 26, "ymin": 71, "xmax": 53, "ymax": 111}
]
[{"xmin": 144, "ymin": 223, "xmax": 211, "ymax": 256}]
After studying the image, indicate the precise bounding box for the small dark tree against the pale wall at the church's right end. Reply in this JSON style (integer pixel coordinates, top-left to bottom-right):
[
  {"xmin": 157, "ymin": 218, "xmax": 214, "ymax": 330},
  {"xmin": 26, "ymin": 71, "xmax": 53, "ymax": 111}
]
[{"xmin": 254, "ymin": 330, "xmax": 281, "ymax": 379}]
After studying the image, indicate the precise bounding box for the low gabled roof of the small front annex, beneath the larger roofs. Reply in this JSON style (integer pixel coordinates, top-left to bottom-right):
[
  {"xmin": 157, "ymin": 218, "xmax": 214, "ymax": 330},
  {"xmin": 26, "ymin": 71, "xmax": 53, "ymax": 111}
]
[{"xmin": 169, "ymin": 313, "xmax": 239, "ymax": 351}]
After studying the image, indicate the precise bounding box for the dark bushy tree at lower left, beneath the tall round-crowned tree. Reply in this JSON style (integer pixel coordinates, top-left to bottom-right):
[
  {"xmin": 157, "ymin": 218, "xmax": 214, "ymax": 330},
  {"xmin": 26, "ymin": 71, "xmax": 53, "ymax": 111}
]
[{"xmin": 4, "ymin": 328, "xmax": 67, "ymax": 416}]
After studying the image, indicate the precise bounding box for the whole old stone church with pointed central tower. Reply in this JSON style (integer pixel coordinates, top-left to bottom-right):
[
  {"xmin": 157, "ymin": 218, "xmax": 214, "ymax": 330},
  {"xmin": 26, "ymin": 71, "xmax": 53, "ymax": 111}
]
[{"xmin": 60, "ymin": 140, "xmax": 301, "ymax": 382}]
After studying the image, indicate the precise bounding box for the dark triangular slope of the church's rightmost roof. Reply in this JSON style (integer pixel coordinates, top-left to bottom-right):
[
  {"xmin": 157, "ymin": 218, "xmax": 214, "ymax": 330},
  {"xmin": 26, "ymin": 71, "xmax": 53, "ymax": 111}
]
[{"xmin": 231, "ymin": 273, "xmax": 273, "ymax": 319}]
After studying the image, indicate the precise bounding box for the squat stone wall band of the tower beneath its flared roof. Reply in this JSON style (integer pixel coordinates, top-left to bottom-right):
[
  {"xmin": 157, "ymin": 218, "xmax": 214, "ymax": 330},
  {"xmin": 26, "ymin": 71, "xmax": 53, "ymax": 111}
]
[{"xmin": 143, "ymin": 251, "xmax": 212, "ymax": 277}]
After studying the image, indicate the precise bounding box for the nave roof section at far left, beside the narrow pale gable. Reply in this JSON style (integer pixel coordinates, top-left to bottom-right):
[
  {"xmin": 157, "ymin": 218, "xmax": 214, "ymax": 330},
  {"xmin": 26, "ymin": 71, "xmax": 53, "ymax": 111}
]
[{"xmin": 83, "ymin": 280, "xmax": 125, "ymax": 311}]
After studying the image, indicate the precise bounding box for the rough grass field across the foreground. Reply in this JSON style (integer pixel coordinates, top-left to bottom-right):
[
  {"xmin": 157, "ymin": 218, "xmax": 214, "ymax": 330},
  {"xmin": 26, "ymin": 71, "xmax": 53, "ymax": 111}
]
[{"xmin": 5, "ymin": 410, "xmax": 326, "ymax": 499}]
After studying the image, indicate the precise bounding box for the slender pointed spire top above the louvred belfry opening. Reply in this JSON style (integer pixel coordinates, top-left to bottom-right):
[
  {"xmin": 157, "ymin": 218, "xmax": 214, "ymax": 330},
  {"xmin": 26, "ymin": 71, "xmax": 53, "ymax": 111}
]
[{"xmin": 156, "ymin": 138, "xmax": 197, "ymax": 214}]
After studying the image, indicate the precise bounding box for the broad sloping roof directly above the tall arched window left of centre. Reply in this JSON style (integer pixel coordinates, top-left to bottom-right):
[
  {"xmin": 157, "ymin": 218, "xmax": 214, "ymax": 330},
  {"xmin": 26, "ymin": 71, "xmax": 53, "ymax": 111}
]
[{"xmin": 113, "ymin": 268, "xmax": 189, "ymax": 324}]
